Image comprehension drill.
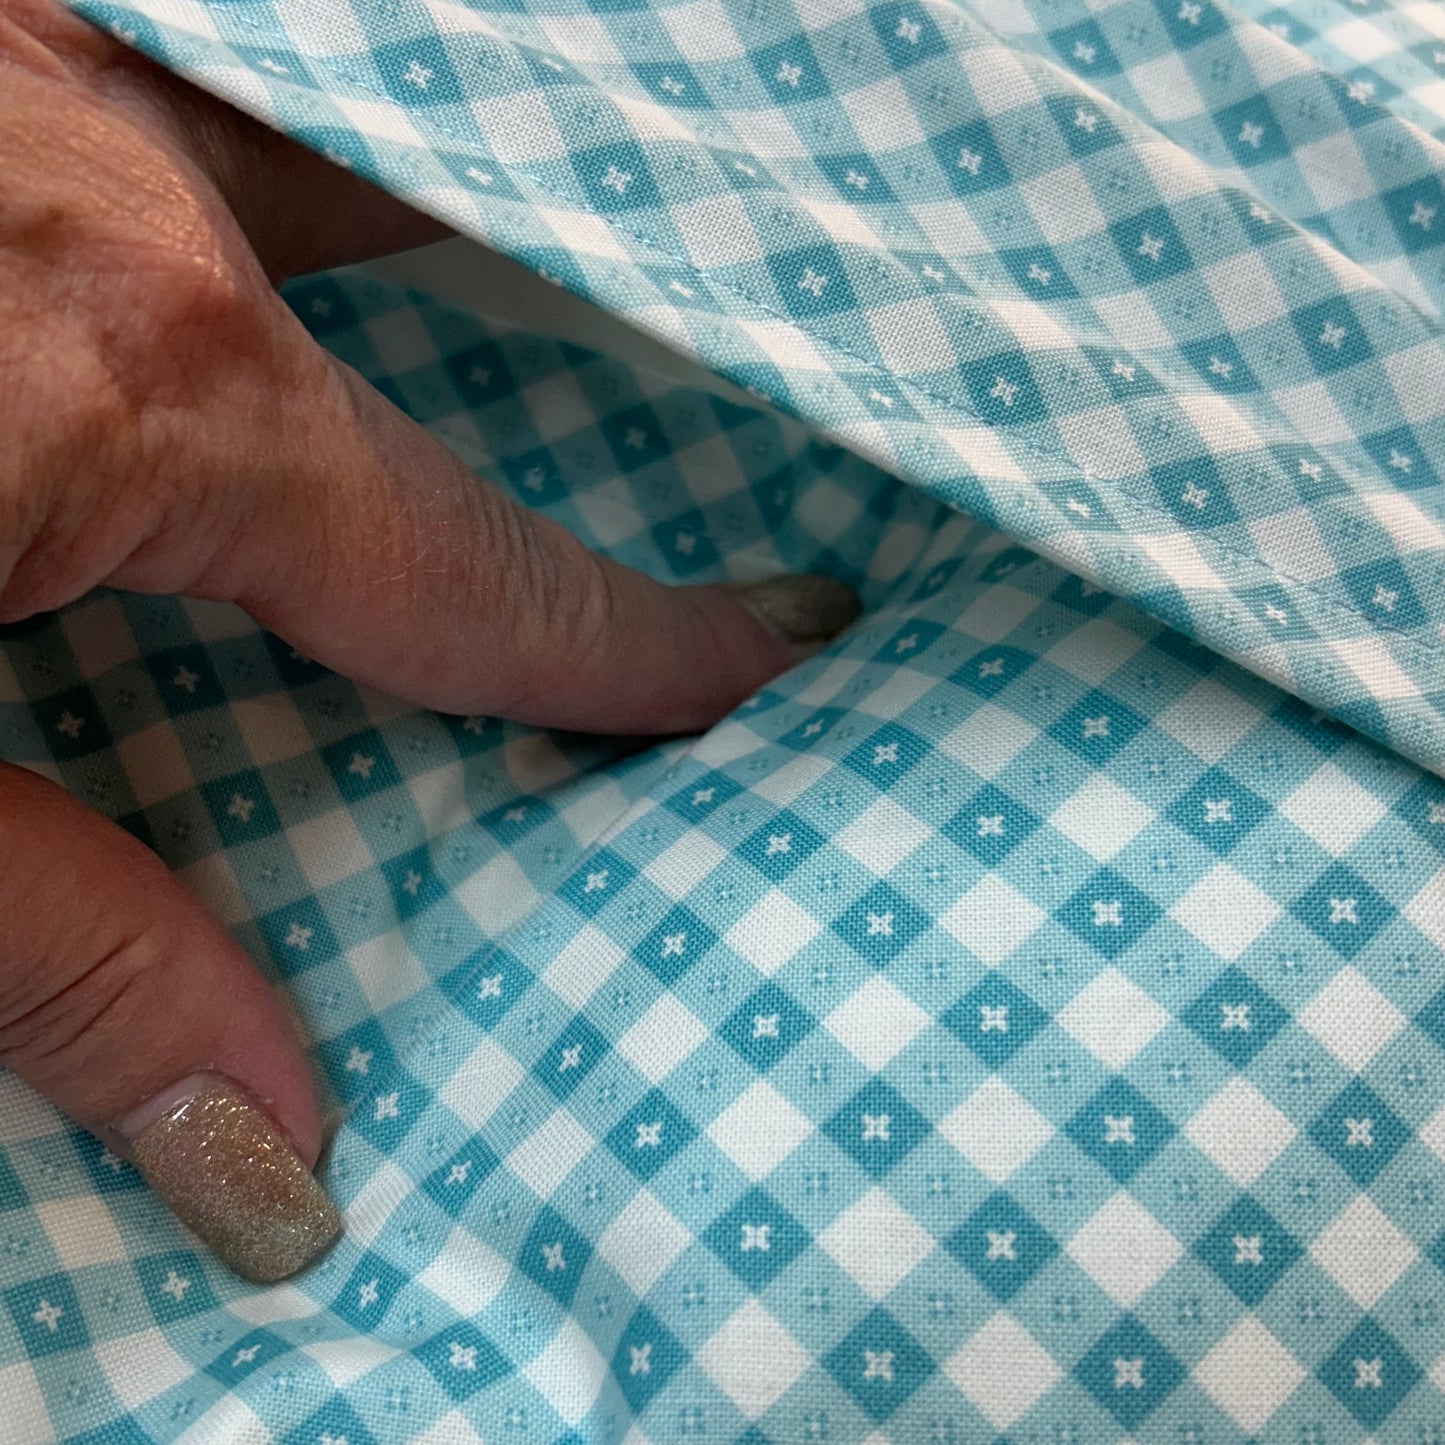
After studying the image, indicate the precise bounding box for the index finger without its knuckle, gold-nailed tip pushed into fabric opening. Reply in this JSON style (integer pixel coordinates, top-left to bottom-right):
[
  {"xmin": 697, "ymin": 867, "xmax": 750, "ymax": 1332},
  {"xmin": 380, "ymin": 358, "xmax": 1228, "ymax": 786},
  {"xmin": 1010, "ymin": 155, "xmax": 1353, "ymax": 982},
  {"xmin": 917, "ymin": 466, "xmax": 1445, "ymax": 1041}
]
[{"xmin": 182, "ymin": 349, "xmax": 857, "ymax": 733}]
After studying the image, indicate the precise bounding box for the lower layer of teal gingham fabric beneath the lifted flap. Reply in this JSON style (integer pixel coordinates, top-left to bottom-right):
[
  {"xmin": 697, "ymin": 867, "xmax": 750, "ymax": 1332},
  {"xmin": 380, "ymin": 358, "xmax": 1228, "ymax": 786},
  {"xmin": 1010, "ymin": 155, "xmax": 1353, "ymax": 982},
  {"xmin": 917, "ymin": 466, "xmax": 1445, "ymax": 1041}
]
[{"xmin": 8, "ymin": 192, "xmax": 1445, "ymax": 1445}]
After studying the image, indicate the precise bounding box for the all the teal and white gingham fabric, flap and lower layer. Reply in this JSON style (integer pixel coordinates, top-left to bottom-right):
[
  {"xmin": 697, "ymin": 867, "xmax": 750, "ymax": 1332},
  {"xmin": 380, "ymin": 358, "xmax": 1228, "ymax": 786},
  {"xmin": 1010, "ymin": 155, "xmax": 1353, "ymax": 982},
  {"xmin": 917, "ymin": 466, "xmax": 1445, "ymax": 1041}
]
[{"xmin": 8, "ymin": 0, "xmax": 1445, "ymax": 1445}]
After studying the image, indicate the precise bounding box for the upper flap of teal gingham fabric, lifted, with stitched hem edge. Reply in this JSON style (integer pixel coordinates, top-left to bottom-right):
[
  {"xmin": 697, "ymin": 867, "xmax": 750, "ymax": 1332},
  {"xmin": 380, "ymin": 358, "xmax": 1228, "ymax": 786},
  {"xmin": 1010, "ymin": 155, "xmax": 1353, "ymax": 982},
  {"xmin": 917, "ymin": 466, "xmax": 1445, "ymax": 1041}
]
[{"xmin": 79, "ymin": 0, "xmax": 1445, "ymax": 770}]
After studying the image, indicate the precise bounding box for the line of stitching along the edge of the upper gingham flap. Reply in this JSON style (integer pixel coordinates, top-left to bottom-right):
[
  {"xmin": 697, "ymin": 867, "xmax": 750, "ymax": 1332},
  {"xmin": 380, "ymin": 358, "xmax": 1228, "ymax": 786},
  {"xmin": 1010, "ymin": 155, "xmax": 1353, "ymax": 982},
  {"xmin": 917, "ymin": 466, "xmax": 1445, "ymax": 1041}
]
[{"xmin": 171, "ymin": 0, "xmax": 1445, "ymax": 684}]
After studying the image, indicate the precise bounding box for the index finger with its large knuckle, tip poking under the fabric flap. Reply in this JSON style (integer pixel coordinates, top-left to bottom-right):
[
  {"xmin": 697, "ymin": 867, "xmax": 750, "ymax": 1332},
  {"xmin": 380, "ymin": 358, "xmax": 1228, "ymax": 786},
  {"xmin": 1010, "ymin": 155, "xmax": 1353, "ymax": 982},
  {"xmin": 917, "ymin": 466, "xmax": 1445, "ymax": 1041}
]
[{"xmin": 0, "ymin": 19, "xmax": 855, "ymax": 733}]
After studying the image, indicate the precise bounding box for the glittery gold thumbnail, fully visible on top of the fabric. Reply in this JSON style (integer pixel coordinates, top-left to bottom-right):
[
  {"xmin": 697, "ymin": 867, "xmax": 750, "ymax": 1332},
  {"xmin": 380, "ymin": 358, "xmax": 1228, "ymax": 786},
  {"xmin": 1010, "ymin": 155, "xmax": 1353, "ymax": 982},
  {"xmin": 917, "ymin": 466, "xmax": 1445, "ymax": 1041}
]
[{"xmin": 116, "ymin": 1074, "xmax": 341, "ymax": 1285}]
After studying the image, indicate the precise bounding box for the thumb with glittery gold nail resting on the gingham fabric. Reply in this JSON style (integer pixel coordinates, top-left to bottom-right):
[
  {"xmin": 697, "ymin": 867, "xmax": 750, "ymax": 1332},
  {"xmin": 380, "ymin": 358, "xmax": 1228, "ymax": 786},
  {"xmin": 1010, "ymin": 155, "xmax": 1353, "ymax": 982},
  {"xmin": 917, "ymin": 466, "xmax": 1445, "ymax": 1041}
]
[{"xmin": 0, "ymin": 764, "xmax": 341, "ymax": 1282}]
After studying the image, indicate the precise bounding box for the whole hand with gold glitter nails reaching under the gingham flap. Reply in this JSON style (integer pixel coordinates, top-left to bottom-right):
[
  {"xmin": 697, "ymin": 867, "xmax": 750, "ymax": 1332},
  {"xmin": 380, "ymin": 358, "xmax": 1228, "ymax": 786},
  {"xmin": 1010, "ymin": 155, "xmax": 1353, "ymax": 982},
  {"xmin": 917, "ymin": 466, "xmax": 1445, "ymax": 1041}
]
[{"xmin": 0, "ymin": 0, "xmax": 855, "ymax": 1280}]
